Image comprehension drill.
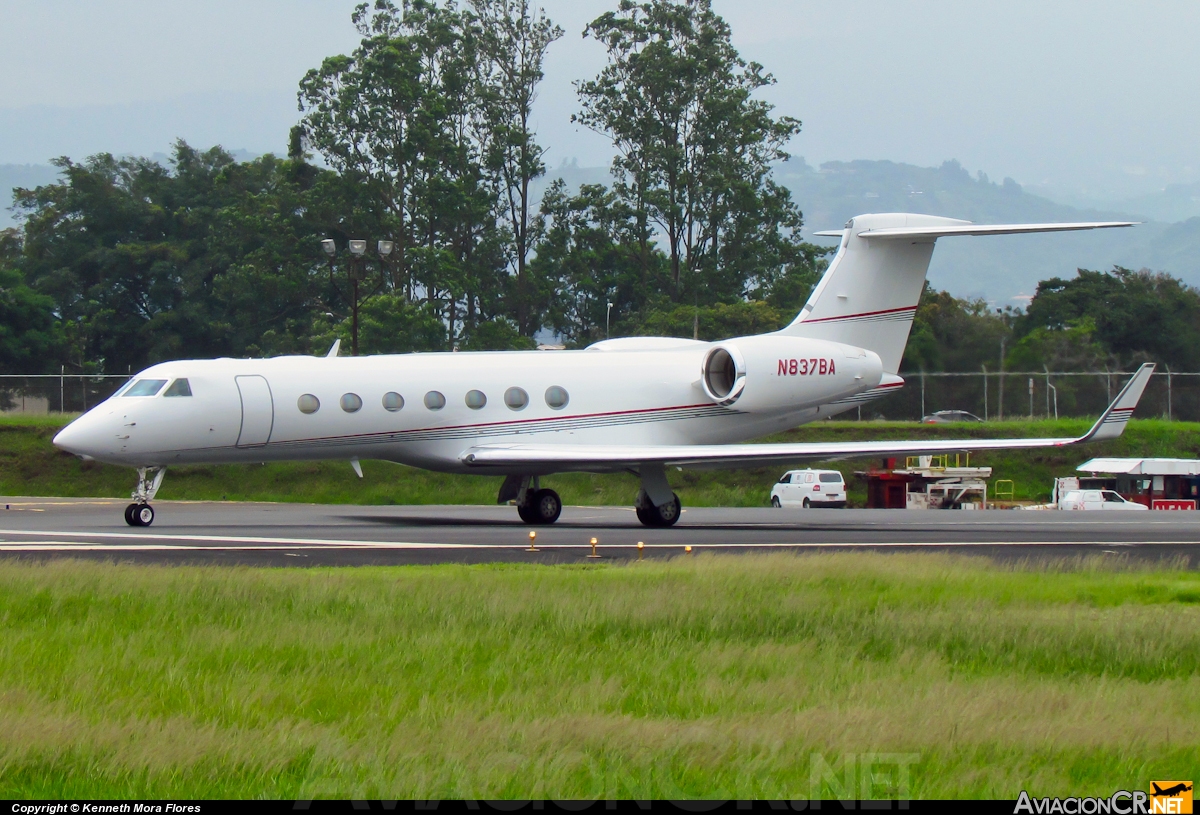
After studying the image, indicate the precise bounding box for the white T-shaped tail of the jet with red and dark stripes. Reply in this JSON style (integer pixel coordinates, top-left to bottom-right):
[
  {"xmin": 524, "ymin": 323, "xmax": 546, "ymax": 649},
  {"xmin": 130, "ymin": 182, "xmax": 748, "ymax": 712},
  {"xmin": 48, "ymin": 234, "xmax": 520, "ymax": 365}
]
[{"xmin": 780, "ymin": 212, "xmax": 1134, "ymax": 374}]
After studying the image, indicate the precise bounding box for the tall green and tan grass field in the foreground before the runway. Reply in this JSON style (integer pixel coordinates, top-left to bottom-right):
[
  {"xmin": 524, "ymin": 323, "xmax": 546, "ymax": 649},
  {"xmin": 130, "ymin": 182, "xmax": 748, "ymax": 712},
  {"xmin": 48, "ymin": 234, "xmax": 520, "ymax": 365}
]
[{"xmin": 0, "ymin": 555, "xmax": 1200, "ymax": 798}]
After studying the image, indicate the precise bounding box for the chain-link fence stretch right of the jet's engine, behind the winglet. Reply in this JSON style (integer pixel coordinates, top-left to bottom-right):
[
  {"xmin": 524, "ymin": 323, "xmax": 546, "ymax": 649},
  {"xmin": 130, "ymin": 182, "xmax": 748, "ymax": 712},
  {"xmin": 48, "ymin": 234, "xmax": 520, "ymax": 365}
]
[{"xmin": 863, "ymin": 371, "xmax": 1200, "ymax": 421}]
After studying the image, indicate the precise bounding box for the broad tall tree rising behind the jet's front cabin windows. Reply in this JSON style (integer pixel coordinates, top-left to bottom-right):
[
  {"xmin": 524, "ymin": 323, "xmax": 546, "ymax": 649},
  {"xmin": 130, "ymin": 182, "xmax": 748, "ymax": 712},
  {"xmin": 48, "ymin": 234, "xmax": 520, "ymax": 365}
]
[{"xmin": 299, "ymin": 0, "xmax": 540, "ymax": 348}]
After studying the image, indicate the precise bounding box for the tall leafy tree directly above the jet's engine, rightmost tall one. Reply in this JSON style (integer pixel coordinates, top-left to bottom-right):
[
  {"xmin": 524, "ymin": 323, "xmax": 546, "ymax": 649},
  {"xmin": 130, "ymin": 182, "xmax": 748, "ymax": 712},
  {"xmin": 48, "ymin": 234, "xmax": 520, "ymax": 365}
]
[{"xmin": 572, "ymin": 0, "xmax": 820, "ymax": 304}]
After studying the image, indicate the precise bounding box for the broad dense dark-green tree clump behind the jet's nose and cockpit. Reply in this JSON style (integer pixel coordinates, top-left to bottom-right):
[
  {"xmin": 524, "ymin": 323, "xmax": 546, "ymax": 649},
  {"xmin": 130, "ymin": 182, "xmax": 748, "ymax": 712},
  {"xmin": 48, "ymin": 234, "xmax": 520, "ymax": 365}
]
[{"xmin": 13, "ymin": 142, "xmax": 358, "ymax": 373}]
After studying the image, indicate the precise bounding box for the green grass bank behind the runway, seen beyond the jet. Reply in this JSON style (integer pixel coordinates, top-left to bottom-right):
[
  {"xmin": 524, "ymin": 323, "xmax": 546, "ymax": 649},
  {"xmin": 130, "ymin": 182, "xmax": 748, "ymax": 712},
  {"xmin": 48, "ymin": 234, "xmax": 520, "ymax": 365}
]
[{"xmin": 0, "ymin": 415, "xmax": 1200, "ymax": 507}]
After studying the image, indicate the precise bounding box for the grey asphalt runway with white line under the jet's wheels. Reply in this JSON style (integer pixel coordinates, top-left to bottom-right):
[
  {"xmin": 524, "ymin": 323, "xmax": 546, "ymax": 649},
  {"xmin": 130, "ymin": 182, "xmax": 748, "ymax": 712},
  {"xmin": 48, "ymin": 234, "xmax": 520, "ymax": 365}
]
[{"xmin": 0, "ymin": 498, "xmax": 1200, "ymax": 569}]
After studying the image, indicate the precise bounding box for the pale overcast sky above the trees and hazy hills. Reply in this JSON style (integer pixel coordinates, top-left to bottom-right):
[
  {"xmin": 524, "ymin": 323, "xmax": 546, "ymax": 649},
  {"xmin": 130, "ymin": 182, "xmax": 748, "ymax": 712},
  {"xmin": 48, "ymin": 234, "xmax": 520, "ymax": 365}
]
[{"xmin": 0, "ymin": 0, "xmax": 1200, "ymax": 198}]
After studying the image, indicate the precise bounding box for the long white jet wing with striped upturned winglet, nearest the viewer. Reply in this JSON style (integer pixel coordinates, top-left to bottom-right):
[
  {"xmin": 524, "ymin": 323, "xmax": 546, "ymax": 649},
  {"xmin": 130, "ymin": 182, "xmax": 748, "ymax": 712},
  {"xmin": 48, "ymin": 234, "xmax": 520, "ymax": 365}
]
[{"xmin": 461, "ymin": 362, "xmax": 1154, "ymax": 472}]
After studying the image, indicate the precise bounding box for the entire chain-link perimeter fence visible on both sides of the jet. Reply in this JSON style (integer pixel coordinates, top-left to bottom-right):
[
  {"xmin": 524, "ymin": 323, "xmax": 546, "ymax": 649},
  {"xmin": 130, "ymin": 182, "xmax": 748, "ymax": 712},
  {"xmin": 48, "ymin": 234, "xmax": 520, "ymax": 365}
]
[{"xmin": 0, "ymin": 371, "xmax": 1200, "ymax": 421}]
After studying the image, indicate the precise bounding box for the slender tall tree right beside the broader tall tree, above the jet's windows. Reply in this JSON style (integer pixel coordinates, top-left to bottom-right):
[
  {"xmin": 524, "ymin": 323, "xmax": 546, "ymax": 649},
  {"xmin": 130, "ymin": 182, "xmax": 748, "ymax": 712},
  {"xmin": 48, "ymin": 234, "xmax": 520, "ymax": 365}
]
[{"xmin": 470, "ymin": 0, "xmax": 563, "ymax": 334}]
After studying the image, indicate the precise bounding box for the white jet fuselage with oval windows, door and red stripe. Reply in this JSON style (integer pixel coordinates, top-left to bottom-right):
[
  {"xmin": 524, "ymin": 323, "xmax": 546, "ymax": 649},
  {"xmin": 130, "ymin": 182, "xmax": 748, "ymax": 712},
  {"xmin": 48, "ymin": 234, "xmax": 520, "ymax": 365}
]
[{"xmin": 55, "ymin": 337, "xmax": 881, "ymax": 474}]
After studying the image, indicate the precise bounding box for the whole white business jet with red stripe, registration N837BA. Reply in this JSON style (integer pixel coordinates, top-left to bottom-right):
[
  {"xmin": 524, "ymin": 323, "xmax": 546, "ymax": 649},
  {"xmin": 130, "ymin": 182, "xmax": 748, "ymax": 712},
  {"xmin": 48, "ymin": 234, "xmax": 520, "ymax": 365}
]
[{"xmin": 54, "ymin": 214, "xmax": 1153, "ymax": 526}]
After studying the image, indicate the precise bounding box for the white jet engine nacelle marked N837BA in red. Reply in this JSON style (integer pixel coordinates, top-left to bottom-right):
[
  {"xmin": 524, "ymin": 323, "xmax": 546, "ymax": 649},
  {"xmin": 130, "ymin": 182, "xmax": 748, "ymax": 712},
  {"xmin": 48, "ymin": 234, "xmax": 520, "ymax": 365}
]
[{"xmin": 700, "ymin": 334, "xmax": 883, "ymax": 413}]
